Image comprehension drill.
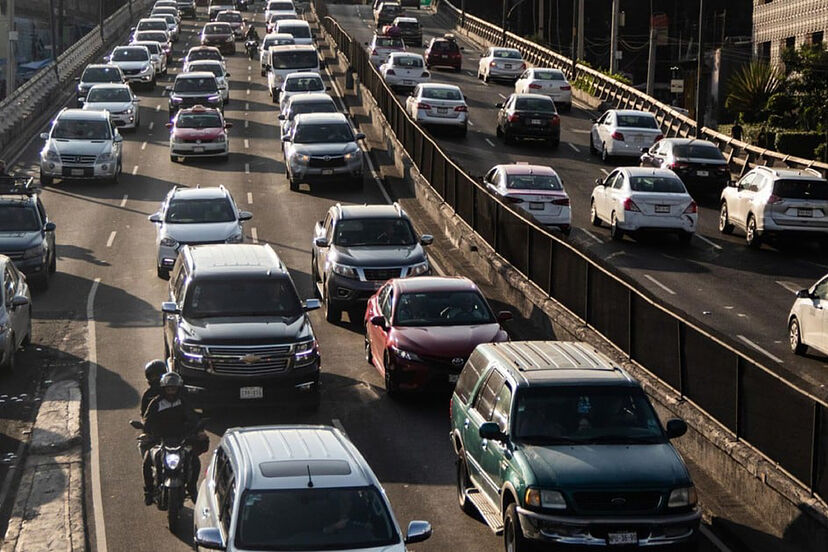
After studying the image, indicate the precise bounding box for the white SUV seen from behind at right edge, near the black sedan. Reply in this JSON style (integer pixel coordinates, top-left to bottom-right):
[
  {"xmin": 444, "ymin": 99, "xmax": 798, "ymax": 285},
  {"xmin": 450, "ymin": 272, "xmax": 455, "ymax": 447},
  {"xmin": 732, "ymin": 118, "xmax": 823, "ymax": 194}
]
[{"xmin": 719, "ymin": 166, "xmax": 828, "ymax": 247}]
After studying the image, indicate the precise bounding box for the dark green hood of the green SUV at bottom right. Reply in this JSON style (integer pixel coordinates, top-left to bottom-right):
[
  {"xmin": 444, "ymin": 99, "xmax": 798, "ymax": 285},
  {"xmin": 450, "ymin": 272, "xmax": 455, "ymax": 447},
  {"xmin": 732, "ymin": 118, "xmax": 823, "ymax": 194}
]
[{"xmin": 519, "ymin": 443, "xmax": 690, "ymax": 489}]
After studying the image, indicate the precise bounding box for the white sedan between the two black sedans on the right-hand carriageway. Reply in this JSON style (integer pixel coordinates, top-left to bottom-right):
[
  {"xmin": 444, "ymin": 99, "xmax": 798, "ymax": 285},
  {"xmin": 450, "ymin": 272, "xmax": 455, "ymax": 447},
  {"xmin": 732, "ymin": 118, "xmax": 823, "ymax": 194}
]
[{"xmin": 589, "ymin": 109, "xmax": 664, "ymax": 163}]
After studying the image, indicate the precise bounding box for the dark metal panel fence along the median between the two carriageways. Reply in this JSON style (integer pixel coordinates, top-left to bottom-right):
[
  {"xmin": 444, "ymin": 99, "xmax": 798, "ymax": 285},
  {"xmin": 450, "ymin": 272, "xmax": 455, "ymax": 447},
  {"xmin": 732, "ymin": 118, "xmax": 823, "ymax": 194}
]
[{"xmin": 314, "ymin": 0, "xmax": 828, "ymax": 502}]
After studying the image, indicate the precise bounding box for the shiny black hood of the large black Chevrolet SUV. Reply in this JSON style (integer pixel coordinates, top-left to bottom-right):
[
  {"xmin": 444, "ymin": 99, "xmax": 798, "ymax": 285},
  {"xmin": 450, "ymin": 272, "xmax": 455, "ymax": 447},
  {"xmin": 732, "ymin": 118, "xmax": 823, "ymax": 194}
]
[{"xmin": 180, "ymin": 313, "xmax": 313, "ymax": 345}]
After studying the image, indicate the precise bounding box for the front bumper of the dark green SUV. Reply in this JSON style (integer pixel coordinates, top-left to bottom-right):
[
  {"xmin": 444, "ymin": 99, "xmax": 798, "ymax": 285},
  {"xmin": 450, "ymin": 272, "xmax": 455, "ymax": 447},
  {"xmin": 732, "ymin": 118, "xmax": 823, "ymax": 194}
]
[{"xmin": 518, "ymin": 508, "xmax": 701, "ymax": 548}]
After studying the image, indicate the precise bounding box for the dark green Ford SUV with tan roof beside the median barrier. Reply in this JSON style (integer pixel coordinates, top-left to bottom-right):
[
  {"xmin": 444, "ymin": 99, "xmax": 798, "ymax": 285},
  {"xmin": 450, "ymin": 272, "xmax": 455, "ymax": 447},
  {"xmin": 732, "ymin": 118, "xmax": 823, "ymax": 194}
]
[{"xmin": 451, "ymin": 341, "xmax": 700, "ymax": 552}]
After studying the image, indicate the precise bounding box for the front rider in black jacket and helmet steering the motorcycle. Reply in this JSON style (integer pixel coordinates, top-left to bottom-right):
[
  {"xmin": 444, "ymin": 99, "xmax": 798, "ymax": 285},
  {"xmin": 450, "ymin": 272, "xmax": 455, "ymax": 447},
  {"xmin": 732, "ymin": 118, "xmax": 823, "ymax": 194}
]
[{"xmin": 143, "ymin": 372, "xmax": 209, "ymax": 506}]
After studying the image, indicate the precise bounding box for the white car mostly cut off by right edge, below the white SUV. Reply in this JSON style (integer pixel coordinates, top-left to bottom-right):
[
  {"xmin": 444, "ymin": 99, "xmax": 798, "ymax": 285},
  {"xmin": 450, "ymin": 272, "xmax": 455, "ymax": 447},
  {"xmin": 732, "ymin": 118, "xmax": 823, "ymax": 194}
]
[{"xmin": 788, "ymin": 276, "xmax": 828, "ymax": 355}]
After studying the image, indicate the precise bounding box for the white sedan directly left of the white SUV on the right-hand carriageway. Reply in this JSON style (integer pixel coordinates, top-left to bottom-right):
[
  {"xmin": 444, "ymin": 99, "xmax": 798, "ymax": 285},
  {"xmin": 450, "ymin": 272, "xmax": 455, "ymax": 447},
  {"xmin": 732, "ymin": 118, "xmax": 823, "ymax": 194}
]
[{"xmin": 590, "ymin": 167, "xmax": 698, "ymax": 243}]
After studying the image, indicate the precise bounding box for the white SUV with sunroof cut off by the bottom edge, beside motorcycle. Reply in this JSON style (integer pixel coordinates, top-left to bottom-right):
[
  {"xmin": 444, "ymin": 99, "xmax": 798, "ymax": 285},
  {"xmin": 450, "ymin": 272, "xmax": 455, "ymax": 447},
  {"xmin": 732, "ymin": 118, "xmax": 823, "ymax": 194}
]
[{"xmin": 193, "ymin": 425, "xmax": 431, "ymax": 552}]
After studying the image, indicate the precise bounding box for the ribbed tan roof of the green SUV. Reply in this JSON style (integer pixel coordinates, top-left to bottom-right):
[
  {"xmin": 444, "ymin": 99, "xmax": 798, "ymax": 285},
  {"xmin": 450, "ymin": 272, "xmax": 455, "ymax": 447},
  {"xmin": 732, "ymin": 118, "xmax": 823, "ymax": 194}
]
[{"xmin": 476, "ymin": 341, "xmax": 638, "ymax": 386}]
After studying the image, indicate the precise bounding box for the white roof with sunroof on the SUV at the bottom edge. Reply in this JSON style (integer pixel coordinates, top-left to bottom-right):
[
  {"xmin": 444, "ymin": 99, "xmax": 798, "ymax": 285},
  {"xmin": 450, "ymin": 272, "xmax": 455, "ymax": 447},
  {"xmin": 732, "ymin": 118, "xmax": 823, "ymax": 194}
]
[{"xmin": 222, "ymin": 425, "xmax": 375, "ymax": 490}]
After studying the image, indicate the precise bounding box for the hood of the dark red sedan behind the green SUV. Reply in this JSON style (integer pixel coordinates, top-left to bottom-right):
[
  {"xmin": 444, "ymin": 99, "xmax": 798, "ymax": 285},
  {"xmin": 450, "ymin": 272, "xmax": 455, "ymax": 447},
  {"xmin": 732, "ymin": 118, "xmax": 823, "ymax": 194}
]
[{"xmin": 390, "ymin": 322, "xmax": 501, "ymax": 359}]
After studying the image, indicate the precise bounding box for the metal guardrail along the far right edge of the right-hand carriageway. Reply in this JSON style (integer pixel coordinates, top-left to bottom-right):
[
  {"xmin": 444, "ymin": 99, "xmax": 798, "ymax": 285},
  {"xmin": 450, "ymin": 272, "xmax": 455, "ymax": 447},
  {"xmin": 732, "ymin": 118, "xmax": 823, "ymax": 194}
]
[{"xmin": 437, "ymin": 0, "xmax": 828, "ymax": 176}]
